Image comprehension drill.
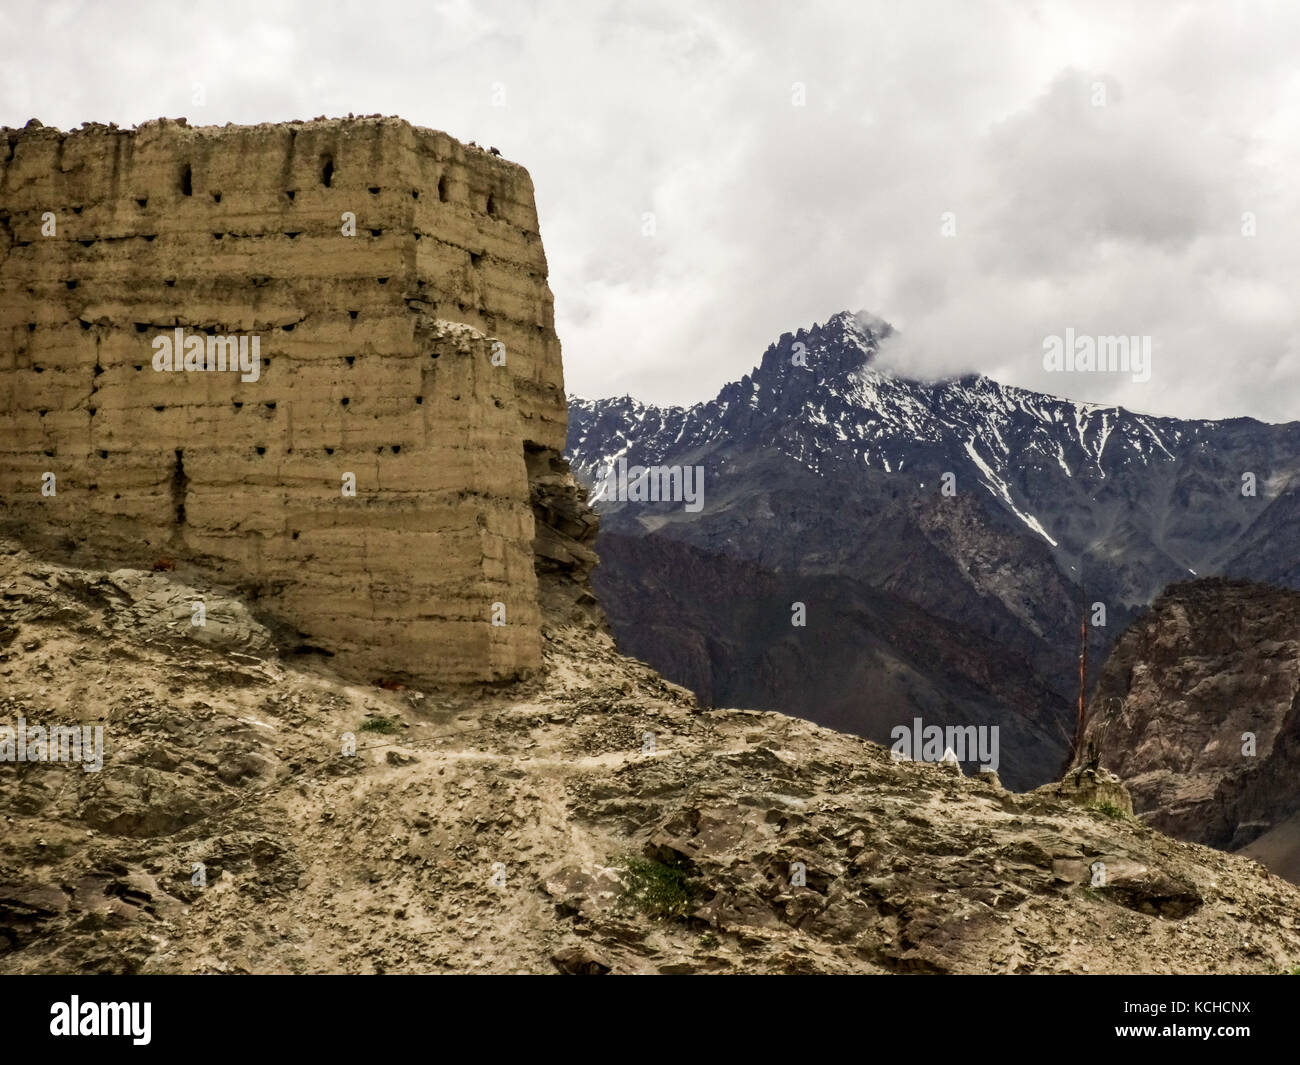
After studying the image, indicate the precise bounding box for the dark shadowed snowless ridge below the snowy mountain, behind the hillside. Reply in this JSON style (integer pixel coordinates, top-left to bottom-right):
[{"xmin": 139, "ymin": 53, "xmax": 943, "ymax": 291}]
[{"xmin": 594, "ymin": 533, "xmax": 1067, "ymax": 789}]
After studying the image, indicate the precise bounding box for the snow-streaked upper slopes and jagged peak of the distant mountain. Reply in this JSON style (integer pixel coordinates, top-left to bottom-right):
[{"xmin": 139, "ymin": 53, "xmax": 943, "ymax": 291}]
[{"xmin": 568, "ymin": 312, "xmax": 1300, "ymax": 605}]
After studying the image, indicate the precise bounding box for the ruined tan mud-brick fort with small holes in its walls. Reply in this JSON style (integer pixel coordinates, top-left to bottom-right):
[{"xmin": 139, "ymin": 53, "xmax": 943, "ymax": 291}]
[{"xmin": 0, "ymin": 118, "xmax": 585, "ymax": 681}]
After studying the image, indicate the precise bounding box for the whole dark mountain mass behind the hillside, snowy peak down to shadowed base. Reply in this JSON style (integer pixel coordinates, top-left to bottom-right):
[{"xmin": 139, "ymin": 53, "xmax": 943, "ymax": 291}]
[{"xmin": 567, "ymin": 313, "xmax": 1300, "ymax": 787}]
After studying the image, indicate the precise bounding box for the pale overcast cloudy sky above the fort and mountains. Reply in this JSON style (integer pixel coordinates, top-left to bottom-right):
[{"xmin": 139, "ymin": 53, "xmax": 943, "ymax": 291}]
[{"xmin": 0, "ymin": 0, "xmax": 1300, "ymax": 420}]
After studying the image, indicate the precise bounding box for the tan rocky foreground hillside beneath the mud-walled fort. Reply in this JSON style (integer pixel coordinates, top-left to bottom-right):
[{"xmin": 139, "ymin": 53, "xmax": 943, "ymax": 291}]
[{"xmin": 0, "ymin": 537, "xmax": 1300, "ymax": 973}]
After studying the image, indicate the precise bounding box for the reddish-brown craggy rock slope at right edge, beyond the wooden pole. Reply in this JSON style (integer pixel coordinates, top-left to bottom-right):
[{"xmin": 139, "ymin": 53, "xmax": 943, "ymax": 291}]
[{"xmin": 1080, "ymin": 579, "xmax": 1300, "ymax": 849}]
